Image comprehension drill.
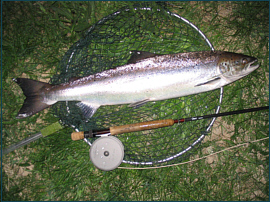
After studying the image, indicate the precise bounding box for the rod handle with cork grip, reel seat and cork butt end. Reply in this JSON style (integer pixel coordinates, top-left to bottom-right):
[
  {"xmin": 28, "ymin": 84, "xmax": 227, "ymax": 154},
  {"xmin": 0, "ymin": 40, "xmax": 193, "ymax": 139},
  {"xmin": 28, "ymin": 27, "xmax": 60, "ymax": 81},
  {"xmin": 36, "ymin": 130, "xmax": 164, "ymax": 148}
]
[{"xmin": 71, "ymin": 119, "xmax": 175, "ymax": 140}]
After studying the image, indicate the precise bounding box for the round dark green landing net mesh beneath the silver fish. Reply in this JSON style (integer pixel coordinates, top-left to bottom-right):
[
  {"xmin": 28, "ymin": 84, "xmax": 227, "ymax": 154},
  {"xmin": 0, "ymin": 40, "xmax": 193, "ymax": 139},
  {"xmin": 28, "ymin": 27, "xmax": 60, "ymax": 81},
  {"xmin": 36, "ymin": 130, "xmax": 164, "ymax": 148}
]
[{"xmin": 51, "ymin": 3, "xmax": 220, "ymax": 165}]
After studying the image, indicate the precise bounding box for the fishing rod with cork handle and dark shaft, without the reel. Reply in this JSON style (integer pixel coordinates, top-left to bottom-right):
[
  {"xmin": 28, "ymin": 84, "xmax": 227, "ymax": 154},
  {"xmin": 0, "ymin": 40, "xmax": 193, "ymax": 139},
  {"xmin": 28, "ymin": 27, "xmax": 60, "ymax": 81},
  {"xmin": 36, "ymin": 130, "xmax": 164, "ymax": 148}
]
[{"xmin": 71, "ymin": 106, "xmax": 269, "ymax": 141}]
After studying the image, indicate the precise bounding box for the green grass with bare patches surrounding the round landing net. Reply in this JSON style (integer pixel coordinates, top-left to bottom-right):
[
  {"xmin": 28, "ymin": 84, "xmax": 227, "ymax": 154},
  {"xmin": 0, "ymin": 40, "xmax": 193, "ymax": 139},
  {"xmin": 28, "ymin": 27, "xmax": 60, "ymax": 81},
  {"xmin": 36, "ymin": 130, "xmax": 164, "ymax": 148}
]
[{"xmin": 1, "ymin": 1, "xmax": 269, "ymax": 201}]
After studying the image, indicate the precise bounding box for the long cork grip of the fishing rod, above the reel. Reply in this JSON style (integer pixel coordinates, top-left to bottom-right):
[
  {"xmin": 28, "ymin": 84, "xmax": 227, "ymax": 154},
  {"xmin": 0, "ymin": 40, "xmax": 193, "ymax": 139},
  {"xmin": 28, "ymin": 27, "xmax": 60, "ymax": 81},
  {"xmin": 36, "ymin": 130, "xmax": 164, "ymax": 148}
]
[{"xmin": 110, "ymin": 119, "xmax": 174, "ymax": 135}]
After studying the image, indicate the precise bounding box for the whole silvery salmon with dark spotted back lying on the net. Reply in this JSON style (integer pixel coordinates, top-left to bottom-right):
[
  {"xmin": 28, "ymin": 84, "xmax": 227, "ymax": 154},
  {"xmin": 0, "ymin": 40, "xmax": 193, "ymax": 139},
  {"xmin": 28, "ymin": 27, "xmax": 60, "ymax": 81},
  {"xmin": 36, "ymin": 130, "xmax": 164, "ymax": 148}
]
[{"xmin": 13, "ymin": 51, "xmax": 260, "ymax": 119}]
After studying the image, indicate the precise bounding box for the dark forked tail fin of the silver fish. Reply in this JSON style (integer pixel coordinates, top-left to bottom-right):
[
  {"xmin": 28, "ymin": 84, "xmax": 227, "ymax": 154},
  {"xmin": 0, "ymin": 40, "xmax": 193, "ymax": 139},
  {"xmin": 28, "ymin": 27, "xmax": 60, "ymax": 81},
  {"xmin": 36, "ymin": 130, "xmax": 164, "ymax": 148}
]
[{"xmin": 13, "ymin": 78, "xmax": 51, "ymax": 119}]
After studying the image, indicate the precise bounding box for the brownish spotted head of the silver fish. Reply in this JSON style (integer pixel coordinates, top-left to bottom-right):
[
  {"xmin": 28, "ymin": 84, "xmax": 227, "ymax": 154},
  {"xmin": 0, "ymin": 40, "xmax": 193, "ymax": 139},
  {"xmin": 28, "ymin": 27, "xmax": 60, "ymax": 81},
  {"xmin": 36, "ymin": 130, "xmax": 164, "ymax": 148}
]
[{"xmin": 218, "ymin": 52, "xmax": 260, "ymax": 82}]
